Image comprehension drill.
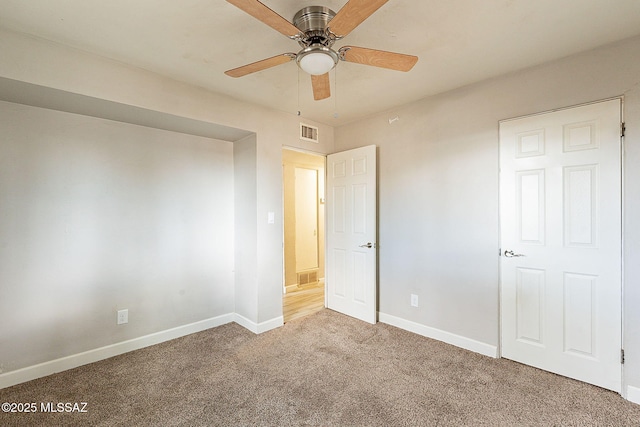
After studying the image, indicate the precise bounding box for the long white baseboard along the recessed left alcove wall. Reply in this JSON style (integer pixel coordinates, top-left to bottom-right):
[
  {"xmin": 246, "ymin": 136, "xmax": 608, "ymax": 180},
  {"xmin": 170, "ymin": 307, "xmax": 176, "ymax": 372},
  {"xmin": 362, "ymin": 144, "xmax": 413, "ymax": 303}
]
[{"xmin": 0, "ymin": 313, "xmax": 234, "ymax": 389}]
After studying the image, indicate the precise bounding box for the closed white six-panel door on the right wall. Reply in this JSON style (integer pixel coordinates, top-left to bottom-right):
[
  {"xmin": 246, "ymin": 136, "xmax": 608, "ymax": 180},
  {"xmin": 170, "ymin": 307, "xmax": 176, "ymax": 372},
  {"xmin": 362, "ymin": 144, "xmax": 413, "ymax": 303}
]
[{"xmin": 500, "ymin": 99, "xmax": 622, "ymax": 392}]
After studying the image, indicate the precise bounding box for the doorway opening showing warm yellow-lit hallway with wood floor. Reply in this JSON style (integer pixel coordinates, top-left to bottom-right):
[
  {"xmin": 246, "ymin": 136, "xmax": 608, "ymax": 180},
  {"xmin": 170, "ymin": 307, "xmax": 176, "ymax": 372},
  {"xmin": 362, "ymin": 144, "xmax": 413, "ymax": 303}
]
[{"xmin": 282, "ymin": 149, "xmax": 325, "ymax": 323}]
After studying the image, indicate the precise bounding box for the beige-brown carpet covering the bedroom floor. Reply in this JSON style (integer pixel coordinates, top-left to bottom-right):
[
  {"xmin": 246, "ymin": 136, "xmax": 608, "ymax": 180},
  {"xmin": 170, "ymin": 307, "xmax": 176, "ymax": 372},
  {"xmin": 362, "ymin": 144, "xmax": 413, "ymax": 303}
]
[{"xmin": 0, "ymin": 310, "xmax": 640, "ymax": 426}]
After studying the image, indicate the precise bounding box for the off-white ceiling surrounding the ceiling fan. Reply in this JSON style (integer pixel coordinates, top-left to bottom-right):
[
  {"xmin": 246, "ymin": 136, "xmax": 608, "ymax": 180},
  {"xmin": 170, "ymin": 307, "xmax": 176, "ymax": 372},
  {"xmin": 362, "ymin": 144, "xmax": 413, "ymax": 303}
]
[{"xmin": 0, "ymin": 0, "xmax": 640, "ymax": 125}]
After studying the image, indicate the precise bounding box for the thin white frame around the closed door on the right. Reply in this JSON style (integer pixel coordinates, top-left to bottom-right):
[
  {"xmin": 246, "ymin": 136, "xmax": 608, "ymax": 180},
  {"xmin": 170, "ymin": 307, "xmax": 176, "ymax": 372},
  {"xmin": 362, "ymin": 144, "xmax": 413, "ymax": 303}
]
[{"xmin": 497, "ymin": 95, "xmax": 627, "ymax": 398}]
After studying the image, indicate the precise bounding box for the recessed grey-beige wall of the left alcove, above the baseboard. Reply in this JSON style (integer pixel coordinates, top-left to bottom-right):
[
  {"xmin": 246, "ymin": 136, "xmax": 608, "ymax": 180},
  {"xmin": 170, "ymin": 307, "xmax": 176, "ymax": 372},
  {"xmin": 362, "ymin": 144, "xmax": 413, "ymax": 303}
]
[{"xmin": 0, "ymin": 102, "xmax": 234, "ymax": 373}]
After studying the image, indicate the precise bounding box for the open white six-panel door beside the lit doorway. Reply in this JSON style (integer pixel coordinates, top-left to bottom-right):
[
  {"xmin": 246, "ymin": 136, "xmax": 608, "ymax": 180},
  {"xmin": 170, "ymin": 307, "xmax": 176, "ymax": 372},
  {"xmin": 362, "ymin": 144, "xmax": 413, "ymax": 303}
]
[{"xmin": 326, "ymin": 145, "xmax": 377, "ymax": 323}]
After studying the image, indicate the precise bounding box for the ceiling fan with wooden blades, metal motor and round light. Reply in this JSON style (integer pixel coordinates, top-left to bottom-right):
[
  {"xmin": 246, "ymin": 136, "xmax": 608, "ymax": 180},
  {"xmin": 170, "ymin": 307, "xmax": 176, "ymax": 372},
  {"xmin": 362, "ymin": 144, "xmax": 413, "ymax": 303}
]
[{"xmin": 225, "ymin": 0, "xmax": 418, "ymax": 101}]
